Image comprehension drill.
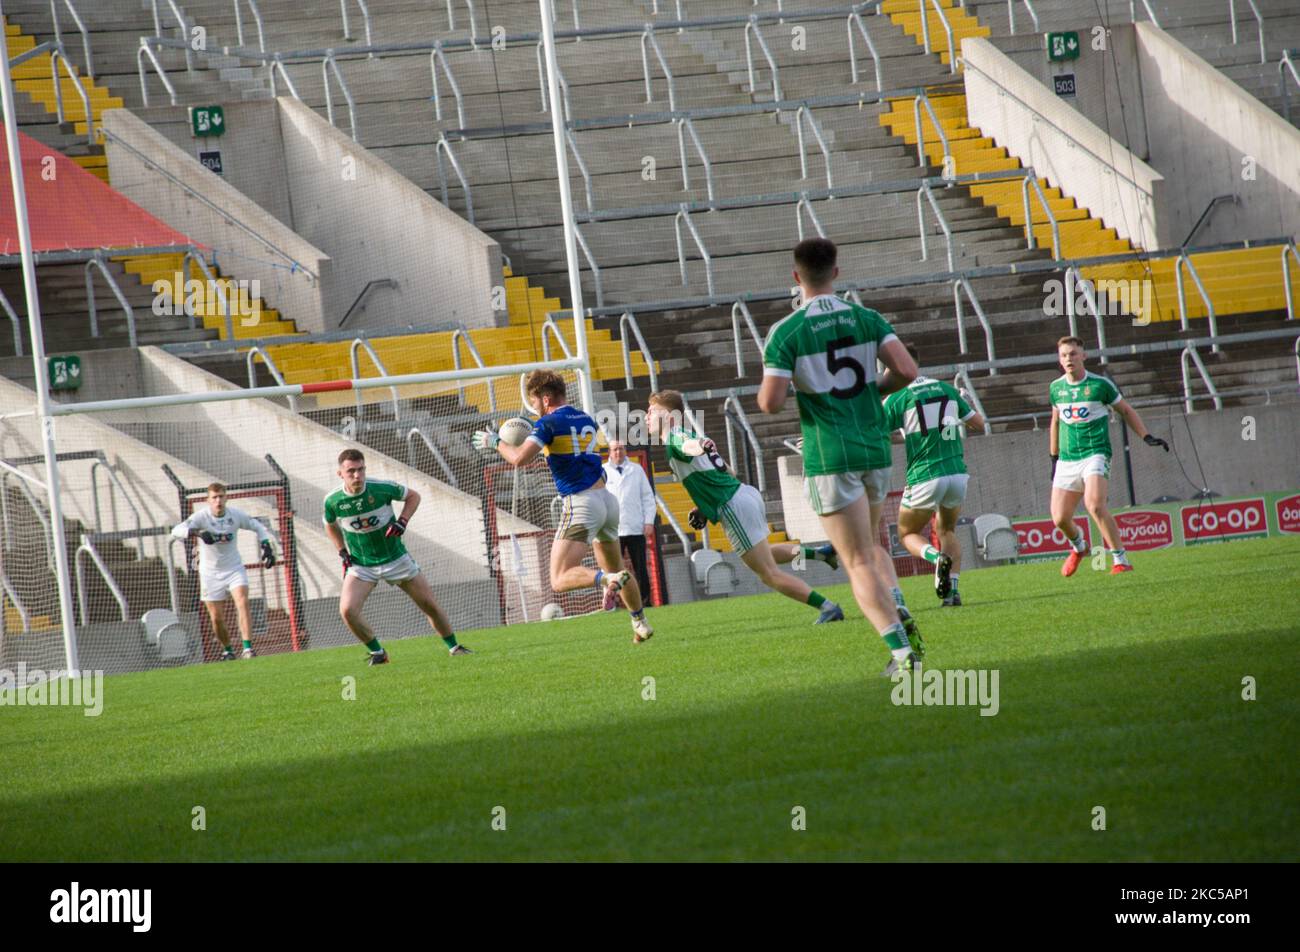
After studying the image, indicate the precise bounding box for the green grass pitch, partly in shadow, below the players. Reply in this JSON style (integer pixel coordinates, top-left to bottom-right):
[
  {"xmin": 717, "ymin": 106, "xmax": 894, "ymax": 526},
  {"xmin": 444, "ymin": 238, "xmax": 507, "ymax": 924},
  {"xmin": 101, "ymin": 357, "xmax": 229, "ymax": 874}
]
[{"xmin": 0, "ymin": 538, "xmax": 1300, "ymax": 861}]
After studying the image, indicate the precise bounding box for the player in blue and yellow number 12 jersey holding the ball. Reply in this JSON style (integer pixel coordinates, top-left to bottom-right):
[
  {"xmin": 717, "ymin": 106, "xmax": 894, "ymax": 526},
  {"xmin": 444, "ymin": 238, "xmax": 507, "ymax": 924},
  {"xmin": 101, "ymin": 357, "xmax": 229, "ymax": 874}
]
[{"xmin": 473, "ymin": 371, "xmax": 654, "ymax": 644}]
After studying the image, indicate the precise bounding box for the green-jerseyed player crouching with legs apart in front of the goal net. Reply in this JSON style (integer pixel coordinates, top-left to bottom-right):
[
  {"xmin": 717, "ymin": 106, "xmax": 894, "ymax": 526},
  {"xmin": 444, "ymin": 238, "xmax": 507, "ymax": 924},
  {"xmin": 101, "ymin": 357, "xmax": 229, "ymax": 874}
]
[{"xmin": 325, "ymin": 450, "xmax": 471, "ymax": 665}]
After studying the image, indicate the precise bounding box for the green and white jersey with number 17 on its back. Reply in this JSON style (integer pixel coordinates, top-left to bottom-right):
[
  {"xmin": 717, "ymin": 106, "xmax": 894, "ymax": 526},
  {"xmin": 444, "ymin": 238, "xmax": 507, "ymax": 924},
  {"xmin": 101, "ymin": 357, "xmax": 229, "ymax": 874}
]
[{"xmin": 885, "ymin": 377, "xmax": 975, "ymax": 486}]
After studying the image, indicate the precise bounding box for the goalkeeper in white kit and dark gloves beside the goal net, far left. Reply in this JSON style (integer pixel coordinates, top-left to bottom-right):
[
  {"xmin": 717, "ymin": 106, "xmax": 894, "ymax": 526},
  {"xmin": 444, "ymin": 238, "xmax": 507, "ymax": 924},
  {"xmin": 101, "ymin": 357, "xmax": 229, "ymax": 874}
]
[{"xmin": 172, "ymin": 483, "xmax": 276, "ymax": 661}]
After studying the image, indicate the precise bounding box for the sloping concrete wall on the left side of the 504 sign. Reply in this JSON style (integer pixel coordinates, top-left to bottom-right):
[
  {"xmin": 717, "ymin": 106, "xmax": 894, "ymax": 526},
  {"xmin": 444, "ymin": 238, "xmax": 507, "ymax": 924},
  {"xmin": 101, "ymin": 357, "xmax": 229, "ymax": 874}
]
[{"xmin": 104, "ymin": 109, "xmax": 332, "ymax": 332}]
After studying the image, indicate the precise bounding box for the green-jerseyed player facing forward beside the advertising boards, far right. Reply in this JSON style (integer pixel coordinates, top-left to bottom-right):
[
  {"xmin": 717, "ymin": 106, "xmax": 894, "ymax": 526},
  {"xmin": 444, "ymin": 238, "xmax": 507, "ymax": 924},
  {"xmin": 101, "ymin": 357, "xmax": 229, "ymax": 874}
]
[{"xmin": 1049, "ymin": 337, "xmax": 1169, "ymax": 576}]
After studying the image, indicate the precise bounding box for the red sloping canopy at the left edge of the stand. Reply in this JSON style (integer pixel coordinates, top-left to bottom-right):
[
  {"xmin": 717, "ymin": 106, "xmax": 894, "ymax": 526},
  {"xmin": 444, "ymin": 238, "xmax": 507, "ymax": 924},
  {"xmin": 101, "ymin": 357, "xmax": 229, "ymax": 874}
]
[{"xmin": 0, "ymin": 125, "xmax": 202, "ymax": 255}]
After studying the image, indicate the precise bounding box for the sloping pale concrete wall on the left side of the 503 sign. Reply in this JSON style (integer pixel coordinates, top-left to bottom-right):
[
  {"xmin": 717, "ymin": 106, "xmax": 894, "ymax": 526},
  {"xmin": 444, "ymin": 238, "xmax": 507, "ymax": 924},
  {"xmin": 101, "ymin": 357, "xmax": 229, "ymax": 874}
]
[{"xmin": 957, "ymin": 36, "xmax": 1166, "ymax": 248}]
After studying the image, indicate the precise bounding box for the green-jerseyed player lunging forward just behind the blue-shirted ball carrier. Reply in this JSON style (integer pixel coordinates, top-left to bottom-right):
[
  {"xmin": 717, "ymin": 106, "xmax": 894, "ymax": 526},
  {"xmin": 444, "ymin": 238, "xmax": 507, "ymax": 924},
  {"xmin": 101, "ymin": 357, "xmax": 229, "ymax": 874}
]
[{"xmin": 646, "ymin": 390, "xmax": 844, "ymax": 624}]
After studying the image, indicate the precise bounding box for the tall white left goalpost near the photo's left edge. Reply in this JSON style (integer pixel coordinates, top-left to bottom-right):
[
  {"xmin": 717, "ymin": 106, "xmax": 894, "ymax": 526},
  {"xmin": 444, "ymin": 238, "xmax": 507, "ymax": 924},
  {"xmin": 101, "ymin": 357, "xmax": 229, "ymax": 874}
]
[{"xmin": 0, "ymin": 4, "xmax": 81, "ymax": 672}]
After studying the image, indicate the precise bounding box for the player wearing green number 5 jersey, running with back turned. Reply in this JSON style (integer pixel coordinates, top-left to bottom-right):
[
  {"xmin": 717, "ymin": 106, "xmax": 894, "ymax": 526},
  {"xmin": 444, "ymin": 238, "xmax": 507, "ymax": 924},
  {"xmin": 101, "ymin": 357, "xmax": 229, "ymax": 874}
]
[{"xmin": 758, "ymin": 238, "xmax": 924, "ymax": 676}]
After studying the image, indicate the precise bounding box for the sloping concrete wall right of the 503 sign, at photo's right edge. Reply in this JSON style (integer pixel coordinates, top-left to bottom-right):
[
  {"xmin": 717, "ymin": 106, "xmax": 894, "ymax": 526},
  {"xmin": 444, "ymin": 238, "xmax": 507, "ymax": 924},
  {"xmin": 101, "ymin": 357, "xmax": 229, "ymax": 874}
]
[{"xmin": 1138, "ymin": 22, "xmax": 1300, "ymax": 246}]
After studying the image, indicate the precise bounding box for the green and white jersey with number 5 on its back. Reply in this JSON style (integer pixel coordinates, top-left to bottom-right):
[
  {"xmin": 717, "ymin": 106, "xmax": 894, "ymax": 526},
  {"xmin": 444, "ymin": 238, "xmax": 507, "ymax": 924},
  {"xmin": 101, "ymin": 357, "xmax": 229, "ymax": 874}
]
[{"xmin": 763, "ymin": 294, "xmax": 898, "ymax": 476}]
